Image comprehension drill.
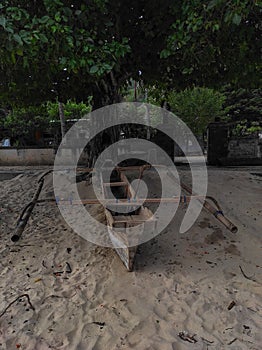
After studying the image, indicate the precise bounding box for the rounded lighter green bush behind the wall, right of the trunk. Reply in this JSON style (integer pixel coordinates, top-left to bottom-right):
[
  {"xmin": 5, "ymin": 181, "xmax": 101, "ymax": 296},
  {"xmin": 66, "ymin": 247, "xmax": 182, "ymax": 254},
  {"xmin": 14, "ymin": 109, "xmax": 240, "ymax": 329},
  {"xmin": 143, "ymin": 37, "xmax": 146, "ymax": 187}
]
[{"xmin": 168, "ymin": 87, "xmax": 226, "ymax": 135}]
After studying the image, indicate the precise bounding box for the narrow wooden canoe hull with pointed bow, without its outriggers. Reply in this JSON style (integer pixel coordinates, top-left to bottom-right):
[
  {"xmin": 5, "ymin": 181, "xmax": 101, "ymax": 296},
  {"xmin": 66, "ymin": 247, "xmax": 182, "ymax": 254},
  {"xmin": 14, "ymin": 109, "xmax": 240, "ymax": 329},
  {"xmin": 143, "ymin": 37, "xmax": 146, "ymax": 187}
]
[{"xmin": 101, "ymin": 169, "xmax": 157, "ymax": 271}]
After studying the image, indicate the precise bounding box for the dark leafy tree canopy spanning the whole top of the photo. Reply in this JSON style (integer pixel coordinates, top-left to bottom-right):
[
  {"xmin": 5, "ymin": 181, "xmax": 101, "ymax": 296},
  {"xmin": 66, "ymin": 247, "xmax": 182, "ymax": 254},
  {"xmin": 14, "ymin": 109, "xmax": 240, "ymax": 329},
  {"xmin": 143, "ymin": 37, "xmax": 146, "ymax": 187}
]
[{"xmin": 0, "ymin": 0, "xmax": 261, "ymax": 106}]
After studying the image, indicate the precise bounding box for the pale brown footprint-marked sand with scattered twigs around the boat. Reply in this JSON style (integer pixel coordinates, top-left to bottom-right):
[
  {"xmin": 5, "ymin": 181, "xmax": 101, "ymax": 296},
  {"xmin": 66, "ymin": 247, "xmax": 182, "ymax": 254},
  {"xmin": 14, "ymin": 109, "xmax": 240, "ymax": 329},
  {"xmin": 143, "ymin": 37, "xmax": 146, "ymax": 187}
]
[{"xmin": 0, "ymin": 167, "xmax": 262, "ymax": 350}]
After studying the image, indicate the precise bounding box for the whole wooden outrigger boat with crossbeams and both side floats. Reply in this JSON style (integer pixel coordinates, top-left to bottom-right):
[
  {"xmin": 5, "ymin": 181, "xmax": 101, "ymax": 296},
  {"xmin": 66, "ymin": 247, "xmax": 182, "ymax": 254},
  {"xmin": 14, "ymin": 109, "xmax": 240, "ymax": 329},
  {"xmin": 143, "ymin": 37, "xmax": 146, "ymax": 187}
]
[{"xmin": 11, "ymin": 165, "xmax": 238, "ymax": 271}]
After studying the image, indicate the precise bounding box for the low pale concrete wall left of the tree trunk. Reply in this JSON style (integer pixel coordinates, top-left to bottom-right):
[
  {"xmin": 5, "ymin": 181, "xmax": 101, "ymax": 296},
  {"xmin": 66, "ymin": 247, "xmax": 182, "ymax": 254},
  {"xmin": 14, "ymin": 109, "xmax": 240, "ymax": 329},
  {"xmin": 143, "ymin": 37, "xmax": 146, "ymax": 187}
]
[{"xmin": 0, "ymin": 147, "xmax": 87, "ymax": 166}]
